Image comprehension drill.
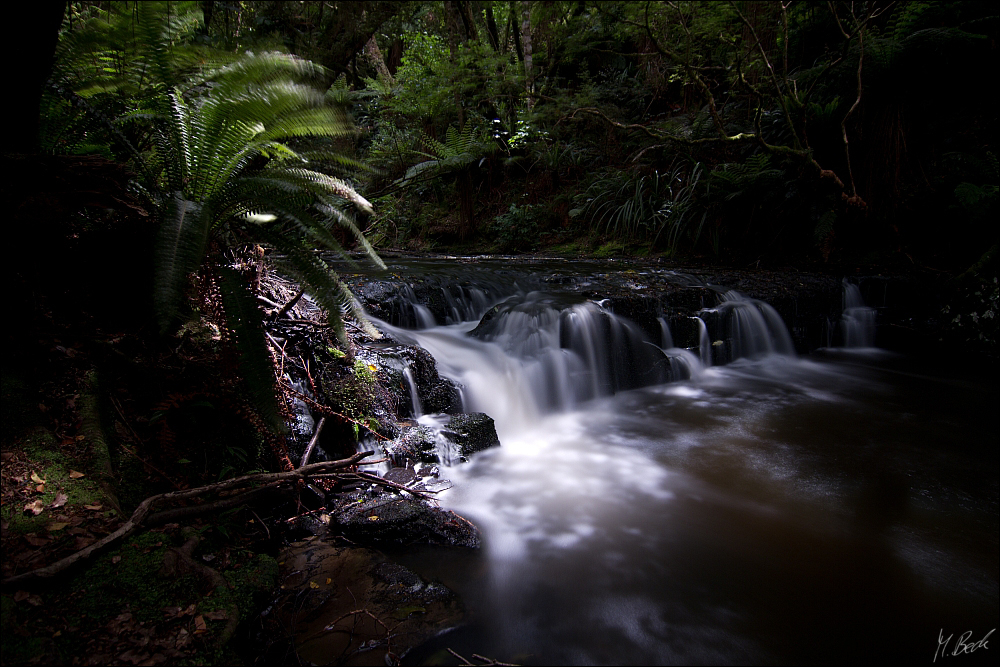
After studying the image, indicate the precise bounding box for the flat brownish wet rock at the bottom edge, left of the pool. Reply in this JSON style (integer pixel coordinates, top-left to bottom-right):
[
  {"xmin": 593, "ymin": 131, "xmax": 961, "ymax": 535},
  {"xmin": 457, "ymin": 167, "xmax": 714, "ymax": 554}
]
[{"xmin": 274, "ymin": 540, "xmax": 464, "ymax": 665}]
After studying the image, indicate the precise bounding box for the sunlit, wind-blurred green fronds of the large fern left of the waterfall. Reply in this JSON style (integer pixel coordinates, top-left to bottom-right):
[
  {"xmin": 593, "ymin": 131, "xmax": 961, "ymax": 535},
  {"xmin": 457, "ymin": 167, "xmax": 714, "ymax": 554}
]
[{"xmin": 147, "ymin": 53, "xmax": 384, "ymax": 340}]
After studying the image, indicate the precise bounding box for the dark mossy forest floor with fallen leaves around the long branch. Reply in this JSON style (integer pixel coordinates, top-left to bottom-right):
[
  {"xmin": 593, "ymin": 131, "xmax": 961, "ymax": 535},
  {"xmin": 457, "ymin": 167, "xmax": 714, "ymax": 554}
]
[{"xmin": 0, "ymin": 310, "xmax": 277, "ymax": 665}]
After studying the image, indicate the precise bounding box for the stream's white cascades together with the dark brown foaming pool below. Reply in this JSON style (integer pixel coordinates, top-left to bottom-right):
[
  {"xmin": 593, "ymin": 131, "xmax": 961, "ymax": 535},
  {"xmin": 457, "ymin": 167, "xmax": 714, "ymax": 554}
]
[{"xmin": 340, "ymin": 258, "xmax": 1000, "ymax": 664}]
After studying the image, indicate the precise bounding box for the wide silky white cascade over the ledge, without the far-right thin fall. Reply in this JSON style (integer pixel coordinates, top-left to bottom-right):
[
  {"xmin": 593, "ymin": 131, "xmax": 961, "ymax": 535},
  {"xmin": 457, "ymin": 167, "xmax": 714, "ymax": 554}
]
[{"xmin": 383, "ymin": 274, "xmax": 794, "ymax": 439}]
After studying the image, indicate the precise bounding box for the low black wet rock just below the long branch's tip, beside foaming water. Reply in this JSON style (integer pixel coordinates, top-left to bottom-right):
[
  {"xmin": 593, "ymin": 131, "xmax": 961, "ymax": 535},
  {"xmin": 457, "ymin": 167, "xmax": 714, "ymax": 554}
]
[{"xmin": 330, "ymin": 493, "xmax": 479, "ymax": 549}]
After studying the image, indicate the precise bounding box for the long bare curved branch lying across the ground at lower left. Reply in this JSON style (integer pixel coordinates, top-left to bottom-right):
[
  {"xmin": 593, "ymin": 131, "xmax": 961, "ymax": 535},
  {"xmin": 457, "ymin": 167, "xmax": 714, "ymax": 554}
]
[{"xmin": 2, "ymin": 452, "xmax": 374, "ymax": 588}]
